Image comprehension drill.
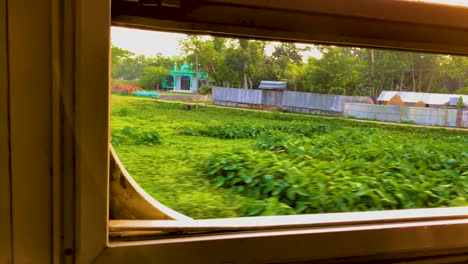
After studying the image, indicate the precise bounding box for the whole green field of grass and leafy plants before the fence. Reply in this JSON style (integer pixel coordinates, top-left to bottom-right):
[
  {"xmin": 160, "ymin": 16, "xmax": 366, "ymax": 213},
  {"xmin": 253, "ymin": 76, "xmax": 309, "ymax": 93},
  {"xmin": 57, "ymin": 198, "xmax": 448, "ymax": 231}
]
[{"xmin": 111, "ymin": 95, "xmax": 468, "ymax": 219}]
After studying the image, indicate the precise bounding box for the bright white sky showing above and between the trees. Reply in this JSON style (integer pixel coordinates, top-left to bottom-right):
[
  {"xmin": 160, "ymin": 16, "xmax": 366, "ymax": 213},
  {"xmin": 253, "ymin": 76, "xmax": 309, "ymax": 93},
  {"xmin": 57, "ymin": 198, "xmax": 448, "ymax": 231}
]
[{"xmin": 111, "ymin": 27, "xmax": 321, "ymax": 60}]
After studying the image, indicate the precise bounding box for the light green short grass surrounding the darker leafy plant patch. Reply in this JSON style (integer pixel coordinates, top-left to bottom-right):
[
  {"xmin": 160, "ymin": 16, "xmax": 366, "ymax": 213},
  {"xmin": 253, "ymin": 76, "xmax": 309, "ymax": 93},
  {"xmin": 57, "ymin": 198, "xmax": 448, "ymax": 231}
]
[{"xmin": 111, "ymin": 95, "xmax": 468, "ymax": 219}]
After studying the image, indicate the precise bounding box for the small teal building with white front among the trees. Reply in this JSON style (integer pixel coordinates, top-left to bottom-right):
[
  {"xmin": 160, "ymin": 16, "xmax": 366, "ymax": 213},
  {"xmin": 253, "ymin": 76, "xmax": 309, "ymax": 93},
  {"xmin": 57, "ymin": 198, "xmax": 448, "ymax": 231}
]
[{"xmin": 161, "ymin": 63, "xmax": 209, "ymax": 92}]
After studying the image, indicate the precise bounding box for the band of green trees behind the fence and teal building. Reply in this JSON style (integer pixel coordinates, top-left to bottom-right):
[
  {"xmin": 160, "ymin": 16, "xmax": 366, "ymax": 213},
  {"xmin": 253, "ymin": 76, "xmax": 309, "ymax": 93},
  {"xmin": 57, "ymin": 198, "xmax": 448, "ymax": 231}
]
[{"xmin": 112, "ymin": 35, "xmax": 468, "ymax": 97}]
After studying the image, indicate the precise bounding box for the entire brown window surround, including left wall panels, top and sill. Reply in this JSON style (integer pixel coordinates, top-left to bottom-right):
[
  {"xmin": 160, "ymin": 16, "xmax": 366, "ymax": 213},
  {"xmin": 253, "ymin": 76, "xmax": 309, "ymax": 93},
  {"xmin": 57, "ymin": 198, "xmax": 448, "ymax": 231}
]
[{"xmin": 0, "ymin": 0, "xmax": 468, "ymax": 264}]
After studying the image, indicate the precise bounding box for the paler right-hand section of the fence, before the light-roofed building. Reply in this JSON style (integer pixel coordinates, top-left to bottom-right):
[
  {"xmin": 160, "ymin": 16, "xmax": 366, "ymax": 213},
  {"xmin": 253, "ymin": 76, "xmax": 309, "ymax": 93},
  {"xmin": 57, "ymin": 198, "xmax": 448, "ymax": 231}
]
[{"xmin": 343, "ymin": 103, "xmax": 468, "ymax": 127}]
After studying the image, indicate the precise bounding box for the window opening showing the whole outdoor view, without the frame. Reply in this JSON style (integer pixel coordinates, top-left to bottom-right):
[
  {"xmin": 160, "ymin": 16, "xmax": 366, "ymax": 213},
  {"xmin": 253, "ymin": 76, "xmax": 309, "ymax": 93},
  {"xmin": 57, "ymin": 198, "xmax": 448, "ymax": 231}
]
[{"xmin": 111, "ymin": 28, "xmax": 468, "ymax": 219}]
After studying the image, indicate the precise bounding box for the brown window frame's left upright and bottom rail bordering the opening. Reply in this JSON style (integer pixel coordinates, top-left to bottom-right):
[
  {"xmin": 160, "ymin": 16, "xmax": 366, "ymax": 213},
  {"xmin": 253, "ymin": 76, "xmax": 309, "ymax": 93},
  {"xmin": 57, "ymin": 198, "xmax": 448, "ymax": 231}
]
[{"xmin": 73, "ymin": 0, "xmax": 468, "ymax": 263}]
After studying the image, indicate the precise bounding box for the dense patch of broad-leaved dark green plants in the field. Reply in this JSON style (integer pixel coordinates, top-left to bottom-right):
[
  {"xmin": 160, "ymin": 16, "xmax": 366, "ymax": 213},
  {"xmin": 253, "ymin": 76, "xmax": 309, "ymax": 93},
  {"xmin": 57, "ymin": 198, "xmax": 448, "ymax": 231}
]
[{"xmin": 199, "ymin": 129, "xmax": 468, "ymax": 215}]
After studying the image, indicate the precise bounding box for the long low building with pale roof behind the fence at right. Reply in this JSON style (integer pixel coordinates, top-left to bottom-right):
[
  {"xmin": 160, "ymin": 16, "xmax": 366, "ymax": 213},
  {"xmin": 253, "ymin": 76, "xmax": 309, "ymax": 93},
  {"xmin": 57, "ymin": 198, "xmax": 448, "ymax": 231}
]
[{"xmin": 377, "ymin": 91, "xmax": 468, "ymax": 108}]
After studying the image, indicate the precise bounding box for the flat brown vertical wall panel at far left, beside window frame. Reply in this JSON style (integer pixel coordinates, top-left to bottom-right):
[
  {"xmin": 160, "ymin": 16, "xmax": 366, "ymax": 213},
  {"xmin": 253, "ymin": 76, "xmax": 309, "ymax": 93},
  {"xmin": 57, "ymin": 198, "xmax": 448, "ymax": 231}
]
[{"xmin": 7, "ymin": 0, "xmax": 52, "ymax": 263}]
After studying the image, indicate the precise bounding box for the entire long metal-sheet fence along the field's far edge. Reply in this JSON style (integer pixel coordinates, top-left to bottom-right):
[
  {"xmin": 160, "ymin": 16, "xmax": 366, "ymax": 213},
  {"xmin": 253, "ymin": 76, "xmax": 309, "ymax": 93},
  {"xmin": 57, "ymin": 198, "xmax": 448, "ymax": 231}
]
[{"xmin": 213, "ymin": 87, "xmax": 468, "ymax": 127}]
